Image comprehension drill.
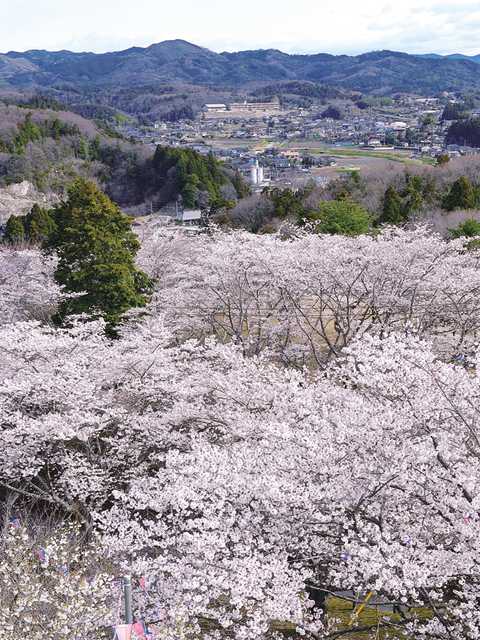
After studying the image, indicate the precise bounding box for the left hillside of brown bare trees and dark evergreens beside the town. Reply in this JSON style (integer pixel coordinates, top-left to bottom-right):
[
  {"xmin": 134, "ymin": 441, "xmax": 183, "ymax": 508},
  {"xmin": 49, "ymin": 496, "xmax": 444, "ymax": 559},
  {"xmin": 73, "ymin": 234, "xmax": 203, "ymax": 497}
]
[{"xmin": 0, "ymin": 103, "xmax": 248, "ymax": 210}]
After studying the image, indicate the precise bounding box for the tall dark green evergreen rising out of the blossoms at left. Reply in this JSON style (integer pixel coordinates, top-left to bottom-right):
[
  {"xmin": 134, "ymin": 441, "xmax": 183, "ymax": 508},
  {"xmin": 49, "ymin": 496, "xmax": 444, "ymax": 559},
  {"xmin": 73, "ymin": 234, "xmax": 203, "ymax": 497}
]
[{"xmin": 48, "ymin": 179, "xmax": 152, "ymax": 332}]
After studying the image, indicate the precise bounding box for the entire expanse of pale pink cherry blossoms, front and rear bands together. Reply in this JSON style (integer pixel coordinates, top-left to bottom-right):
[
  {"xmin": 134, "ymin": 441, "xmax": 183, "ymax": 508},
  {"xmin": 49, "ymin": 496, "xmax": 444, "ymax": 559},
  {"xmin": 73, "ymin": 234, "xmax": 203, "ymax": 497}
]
[{"xmin": 0, "ymin": 229, "xmax": 480, "ymax": 640}]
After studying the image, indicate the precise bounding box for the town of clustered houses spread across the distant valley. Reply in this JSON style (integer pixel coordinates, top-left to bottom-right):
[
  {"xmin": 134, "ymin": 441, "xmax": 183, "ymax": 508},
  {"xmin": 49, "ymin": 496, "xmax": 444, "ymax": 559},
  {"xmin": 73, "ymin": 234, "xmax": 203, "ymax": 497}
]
[{"xmin": 115, "ymin": 93, "xmax": 476, "ymax": 195}]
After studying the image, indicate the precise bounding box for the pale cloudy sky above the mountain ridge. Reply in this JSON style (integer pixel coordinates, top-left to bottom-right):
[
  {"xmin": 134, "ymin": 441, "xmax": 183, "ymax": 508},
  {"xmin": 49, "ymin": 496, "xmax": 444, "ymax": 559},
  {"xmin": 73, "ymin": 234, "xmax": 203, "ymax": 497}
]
[{"xmin": 0, "ymin": 0, "xmax": 480, "ymax": 54}]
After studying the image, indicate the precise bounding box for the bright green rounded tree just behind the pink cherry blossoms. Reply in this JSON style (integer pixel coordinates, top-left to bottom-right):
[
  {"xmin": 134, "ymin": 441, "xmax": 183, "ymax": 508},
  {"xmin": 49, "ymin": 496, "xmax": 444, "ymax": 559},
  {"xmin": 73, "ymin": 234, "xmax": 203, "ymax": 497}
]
[{"xmin": 307, "ymin": 200, "xmax": 372, "ymax": 236}]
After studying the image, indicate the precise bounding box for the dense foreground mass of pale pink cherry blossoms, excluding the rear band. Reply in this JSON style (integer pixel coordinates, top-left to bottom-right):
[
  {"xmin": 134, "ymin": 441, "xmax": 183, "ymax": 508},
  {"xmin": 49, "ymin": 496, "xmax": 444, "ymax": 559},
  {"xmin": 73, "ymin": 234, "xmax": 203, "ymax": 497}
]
[{"xmin": 0, "ymin": 312, "xmax": 480, "ymax": 638}]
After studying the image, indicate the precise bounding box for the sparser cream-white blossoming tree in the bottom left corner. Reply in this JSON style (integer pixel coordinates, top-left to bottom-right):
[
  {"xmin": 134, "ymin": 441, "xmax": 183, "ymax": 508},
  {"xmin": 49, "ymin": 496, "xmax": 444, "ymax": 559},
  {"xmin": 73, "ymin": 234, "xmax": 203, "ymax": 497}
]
[{"xmin": 0, "ymin": 524, "xmax": 113, "ymax": 640}]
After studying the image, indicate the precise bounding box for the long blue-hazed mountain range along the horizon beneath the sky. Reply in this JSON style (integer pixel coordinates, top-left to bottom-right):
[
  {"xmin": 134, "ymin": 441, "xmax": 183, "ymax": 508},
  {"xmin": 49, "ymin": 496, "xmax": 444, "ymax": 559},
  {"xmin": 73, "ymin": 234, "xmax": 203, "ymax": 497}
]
[{"xmin": 0, "ymin": 40, "xmax": 480, "ymax": 94}]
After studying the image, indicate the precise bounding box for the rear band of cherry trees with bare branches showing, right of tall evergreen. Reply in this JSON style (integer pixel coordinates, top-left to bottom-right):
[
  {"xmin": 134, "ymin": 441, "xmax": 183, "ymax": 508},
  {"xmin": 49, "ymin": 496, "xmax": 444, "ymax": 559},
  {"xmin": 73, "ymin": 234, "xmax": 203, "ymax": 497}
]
[{"xmin": 141, "ymin": 228, "xmax": 480, "ymax": 366}]
